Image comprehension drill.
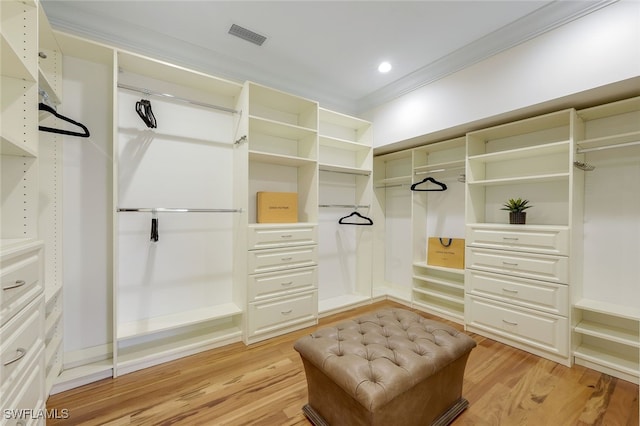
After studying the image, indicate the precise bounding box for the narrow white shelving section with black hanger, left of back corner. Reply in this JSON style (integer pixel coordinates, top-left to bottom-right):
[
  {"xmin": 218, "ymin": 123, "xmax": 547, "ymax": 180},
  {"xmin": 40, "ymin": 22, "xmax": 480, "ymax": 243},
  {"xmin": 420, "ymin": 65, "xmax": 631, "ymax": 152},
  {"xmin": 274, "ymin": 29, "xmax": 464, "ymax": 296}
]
[{"xmin": 318, "ymin": 108, "xmax": 375, "ymax": 315}]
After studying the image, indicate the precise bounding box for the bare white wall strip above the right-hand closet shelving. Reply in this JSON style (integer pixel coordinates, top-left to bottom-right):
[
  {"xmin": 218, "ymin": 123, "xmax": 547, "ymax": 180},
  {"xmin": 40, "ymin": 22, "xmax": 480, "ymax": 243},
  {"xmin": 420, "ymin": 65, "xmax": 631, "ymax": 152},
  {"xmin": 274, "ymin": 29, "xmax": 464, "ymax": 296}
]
[{"xmin": 365, "ymin": 0, "xmax": 640, "ymax": 148}]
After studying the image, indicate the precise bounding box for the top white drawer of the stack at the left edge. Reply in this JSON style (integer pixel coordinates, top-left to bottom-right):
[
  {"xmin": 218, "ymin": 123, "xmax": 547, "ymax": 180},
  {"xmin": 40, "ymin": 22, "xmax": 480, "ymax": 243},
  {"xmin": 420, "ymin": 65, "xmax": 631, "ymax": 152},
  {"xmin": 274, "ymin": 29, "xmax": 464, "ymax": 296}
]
[{"xmin": 0, "ymin": 247, "xmax": 43, "ymax": 325}]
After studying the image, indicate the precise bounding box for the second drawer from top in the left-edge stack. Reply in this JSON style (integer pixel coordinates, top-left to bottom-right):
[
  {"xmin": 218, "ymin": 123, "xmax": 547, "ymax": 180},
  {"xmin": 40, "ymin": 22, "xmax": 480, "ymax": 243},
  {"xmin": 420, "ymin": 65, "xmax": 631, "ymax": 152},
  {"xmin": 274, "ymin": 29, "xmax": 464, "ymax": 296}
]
[{"xmin": 0, "ymin": 296, "xmax": 44, "ymax": 394}]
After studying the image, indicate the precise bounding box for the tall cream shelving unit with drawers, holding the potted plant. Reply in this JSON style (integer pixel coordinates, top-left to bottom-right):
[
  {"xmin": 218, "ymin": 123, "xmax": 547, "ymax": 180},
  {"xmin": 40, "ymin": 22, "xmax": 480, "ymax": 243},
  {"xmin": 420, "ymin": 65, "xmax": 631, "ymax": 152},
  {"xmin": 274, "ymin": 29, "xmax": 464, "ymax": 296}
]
[{"xmin": 465, "ymin": 110, "xmax": 583, "ymax": 365}]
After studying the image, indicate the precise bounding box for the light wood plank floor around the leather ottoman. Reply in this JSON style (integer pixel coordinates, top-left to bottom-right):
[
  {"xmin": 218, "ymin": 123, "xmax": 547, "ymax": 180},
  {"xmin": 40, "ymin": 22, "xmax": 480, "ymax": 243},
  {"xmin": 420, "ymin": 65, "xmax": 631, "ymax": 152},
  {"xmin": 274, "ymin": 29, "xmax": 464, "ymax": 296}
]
[{"xmin": 47, "ymin": 302, "xmax": 639, "ymax": 426}]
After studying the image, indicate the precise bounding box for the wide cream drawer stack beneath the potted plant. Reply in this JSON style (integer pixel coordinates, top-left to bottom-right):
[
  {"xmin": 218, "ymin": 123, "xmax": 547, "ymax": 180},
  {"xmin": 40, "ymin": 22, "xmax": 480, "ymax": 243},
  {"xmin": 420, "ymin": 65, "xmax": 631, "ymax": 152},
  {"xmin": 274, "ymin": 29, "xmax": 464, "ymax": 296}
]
[{"xmin": 465, "ymin": 224, "xmax": 570, "ymax": 365}]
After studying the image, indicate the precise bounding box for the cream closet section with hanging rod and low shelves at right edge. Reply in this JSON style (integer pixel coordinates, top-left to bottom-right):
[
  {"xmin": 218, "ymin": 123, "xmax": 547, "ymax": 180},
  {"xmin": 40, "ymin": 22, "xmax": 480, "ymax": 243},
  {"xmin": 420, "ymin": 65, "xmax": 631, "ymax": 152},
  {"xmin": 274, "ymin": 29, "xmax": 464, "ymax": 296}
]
[{"xmin": 572, "ymin": 97, "xmax": 640, "ymax": 383}]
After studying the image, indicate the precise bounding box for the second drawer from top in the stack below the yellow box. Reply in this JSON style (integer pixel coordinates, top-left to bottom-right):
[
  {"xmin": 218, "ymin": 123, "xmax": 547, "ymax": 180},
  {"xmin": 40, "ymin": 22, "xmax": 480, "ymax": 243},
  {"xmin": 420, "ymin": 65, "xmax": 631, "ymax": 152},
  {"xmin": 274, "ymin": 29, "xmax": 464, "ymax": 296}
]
[{"xmin": 247, "ymin": 246, "xmax": 318, "ymax": 274}]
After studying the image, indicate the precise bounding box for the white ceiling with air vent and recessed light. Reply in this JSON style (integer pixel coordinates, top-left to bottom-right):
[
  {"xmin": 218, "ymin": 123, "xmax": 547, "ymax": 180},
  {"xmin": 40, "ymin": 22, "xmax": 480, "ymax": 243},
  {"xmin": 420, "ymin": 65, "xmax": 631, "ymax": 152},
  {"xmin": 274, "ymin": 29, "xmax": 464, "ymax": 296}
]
[{"xmin": 41, "ymin": 0, "xmax": 614, "ymax": 114}]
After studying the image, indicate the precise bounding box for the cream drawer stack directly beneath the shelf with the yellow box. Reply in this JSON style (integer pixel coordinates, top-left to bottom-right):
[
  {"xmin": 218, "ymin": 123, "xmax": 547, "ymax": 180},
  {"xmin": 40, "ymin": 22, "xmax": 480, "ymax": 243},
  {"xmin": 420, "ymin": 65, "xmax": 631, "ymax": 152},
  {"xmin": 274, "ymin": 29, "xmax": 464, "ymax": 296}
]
[{"xmin": 246, "ymin": 224, "xmax": 318, "ymax": 343}]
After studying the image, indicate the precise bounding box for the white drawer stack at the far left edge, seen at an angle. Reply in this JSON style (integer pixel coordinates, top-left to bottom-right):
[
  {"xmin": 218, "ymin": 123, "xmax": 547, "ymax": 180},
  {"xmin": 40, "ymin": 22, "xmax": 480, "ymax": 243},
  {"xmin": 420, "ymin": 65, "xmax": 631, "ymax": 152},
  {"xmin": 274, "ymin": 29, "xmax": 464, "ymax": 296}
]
[{"xmin": 0, "ymin": 242, "xmax": 46, "ymax": 424}]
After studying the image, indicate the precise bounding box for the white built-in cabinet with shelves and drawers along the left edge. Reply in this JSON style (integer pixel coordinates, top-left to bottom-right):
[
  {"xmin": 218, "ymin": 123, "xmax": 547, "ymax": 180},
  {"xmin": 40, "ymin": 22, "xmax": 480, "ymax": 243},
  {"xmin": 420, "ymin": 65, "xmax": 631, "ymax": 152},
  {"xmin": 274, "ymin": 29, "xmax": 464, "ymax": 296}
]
[{"xmin": 0, "ymin": 1, "xmax": 61, "ymax": 424}]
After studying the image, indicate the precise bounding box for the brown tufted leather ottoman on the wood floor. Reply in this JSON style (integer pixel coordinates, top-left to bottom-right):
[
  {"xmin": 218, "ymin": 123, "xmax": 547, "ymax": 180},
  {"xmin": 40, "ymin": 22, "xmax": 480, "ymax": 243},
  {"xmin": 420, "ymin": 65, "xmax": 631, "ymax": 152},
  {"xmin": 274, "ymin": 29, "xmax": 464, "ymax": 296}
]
[{"xmin": 294, "ymin": 309, "xmax": 476, "ymax": 426}]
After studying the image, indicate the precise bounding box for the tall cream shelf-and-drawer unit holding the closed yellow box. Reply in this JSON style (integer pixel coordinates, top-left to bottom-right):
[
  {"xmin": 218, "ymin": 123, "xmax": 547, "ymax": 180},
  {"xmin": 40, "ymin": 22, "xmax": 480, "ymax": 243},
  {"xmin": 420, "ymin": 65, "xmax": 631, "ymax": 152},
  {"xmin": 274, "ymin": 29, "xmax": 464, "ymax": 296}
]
[{"xmin": 234, "ymin": 82, "xmax": 318, "ymax": 344}]
